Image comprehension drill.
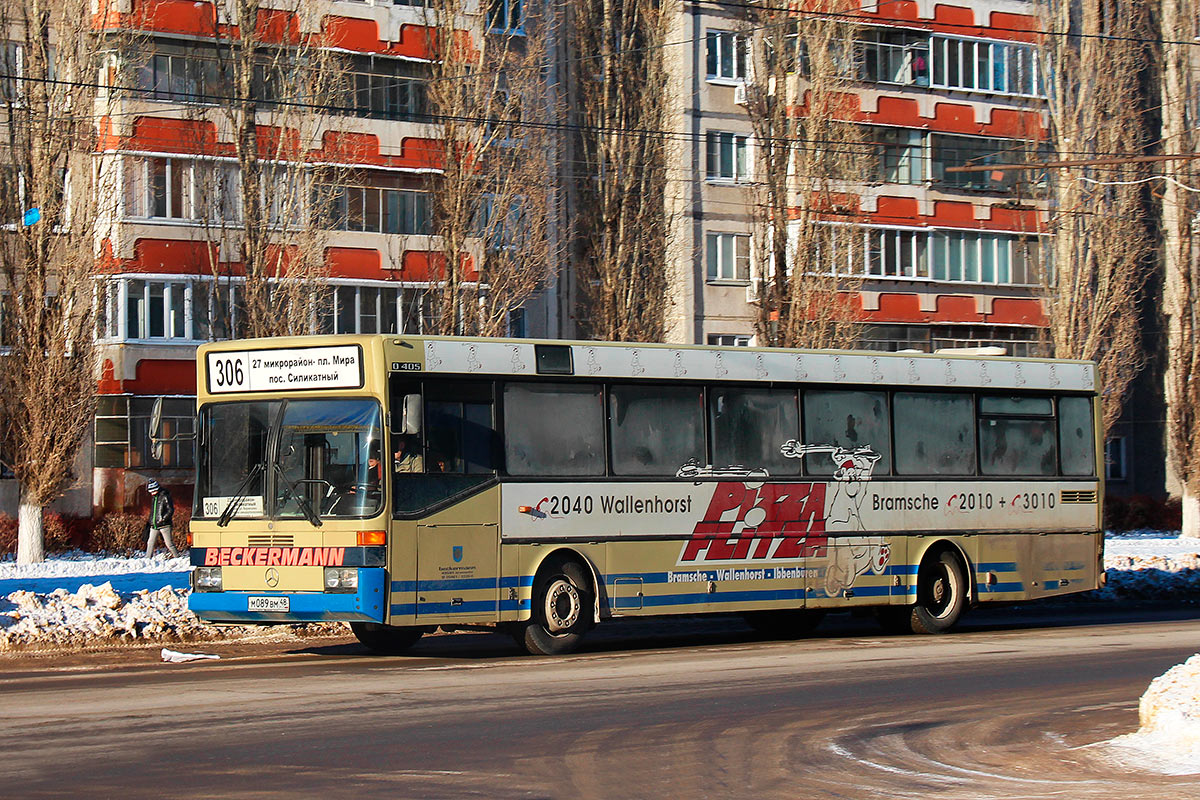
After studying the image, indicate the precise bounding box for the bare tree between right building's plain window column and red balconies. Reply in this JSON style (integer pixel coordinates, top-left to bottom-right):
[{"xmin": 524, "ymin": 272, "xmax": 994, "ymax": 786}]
[{"xmin": 745, "ymin": 6, "xmax": 872, "ymax": 348}]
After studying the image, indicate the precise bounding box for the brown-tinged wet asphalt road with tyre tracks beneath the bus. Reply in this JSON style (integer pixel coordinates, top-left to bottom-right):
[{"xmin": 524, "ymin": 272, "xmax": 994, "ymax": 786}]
[{"xmin": 0, "ymin": 609, "xmax": 1200, "ymax": 800}]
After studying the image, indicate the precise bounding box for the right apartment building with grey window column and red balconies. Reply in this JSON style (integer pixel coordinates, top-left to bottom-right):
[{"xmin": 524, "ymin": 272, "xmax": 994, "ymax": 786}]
[{"xmin": 671, "ymin": 0, "xmax": 1044, "ymax": 355}]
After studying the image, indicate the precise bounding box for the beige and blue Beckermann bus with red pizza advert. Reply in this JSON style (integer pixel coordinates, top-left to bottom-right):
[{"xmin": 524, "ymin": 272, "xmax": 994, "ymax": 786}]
[{"xmin": 188, "ymin": 335, "xmax": 1104, "ymax": 655}]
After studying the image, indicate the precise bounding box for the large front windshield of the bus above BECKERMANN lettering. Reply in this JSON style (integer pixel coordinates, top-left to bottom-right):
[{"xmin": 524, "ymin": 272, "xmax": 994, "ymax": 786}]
[{"xmin": 196, "ymin": 398, "xmax": 383, "ymax": 519}]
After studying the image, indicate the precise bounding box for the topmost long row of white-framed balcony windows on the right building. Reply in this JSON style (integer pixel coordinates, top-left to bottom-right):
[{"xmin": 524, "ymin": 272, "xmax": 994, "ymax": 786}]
[{"xmin": 930, "ymin": 36, "xmax": 1045, "ymax": 97}]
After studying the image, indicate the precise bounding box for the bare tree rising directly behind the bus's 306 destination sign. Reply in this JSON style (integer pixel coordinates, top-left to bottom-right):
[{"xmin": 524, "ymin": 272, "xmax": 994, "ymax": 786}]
[{"xmin": 166, "ymin": 0, "xmax": 340, "ymax": 337}]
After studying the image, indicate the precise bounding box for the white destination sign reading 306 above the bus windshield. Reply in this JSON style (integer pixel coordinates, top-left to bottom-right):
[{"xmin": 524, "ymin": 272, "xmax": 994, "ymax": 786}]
[{"xmin": 205, "ymin": 344, "xmax": 362, "ymax": 395}]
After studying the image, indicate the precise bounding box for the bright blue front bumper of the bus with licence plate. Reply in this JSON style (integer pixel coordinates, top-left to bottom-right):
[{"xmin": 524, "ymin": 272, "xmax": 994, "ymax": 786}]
[{"xmin": 187, "ymin": 567, "xmax": 388, "ymax": 625}]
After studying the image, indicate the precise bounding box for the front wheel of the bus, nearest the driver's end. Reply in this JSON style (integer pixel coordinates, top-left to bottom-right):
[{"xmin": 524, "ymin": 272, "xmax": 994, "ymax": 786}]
[{"xmin": 514, "ymin": 558, "xmax": 594, "ymax": 656}]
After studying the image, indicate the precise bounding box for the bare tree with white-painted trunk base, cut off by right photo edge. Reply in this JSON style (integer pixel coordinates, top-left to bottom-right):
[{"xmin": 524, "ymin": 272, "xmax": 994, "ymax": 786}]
[{"xmin": 1162, "ymin": 0, "xmax": 1200, "ymax": 536}]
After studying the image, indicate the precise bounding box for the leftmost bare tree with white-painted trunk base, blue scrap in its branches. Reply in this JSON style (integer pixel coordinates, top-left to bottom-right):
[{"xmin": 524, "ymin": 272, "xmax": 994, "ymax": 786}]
[{"xmin": 0, "ymin": 0, "xmax": 116, "ymax": 564}]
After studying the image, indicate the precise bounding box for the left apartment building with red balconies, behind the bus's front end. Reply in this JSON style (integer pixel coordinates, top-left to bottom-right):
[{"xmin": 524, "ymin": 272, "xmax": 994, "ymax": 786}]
[{"xmin": 84, "ymin": 0, "xmax": 558, "ymax": 510}]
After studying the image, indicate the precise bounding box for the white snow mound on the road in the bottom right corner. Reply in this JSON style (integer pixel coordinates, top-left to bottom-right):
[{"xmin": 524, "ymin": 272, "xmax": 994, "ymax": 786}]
[{"xmin": 1109, "ymin": 655, "xmax": 1200, "ymax": 775}]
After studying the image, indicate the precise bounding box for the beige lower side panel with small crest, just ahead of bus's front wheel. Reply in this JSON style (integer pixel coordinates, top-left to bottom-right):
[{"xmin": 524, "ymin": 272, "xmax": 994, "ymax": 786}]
[{"xmin": 416, "ymin": 523, "xmax": 499, "ymax": 625}]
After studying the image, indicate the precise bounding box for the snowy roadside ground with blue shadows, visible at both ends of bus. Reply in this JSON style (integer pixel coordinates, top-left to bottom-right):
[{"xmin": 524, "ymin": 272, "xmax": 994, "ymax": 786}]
[{"xmin": 0, "ymin": 531, "xmax": 1200, "ymax": 652}]
